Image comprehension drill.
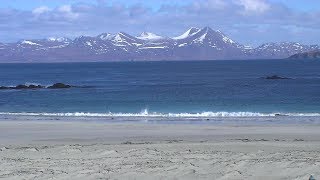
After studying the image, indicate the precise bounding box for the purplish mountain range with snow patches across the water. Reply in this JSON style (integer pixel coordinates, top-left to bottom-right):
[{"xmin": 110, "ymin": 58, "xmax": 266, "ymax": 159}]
[{"xmin": 0, "ymin": 27, "xmax": 320, "ymax": 62}]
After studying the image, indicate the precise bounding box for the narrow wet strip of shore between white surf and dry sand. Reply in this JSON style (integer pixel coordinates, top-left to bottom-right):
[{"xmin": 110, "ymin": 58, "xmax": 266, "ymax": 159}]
[{"xmin": 0, "ymin": 113, "xmax": 320, "ymax": 126}]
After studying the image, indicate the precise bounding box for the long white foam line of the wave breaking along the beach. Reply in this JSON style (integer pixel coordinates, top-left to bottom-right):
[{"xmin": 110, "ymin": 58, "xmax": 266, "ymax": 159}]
[{"xmin": 0, "ymin": 110, "xmax": 320, "ymax": 118}]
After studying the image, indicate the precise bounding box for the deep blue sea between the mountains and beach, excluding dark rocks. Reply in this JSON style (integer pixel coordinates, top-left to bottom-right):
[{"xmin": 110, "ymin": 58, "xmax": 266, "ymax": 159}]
[{"xmin": 0, "ymin": 60, "xmax": 320, "ymax": 117}]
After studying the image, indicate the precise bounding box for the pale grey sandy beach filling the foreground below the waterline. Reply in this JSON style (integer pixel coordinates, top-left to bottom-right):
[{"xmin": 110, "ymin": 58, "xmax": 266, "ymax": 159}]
[{"xmin": 0, "ymin": 120, "xmax": 320, "ymax": 180}]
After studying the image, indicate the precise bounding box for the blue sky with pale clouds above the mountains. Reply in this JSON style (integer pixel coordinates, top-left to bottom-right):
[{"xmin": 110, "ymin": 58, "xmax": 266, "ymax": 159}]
[{"xmin": 0, "ymin": 0, "xmax": 320, "ymax": 46}]
